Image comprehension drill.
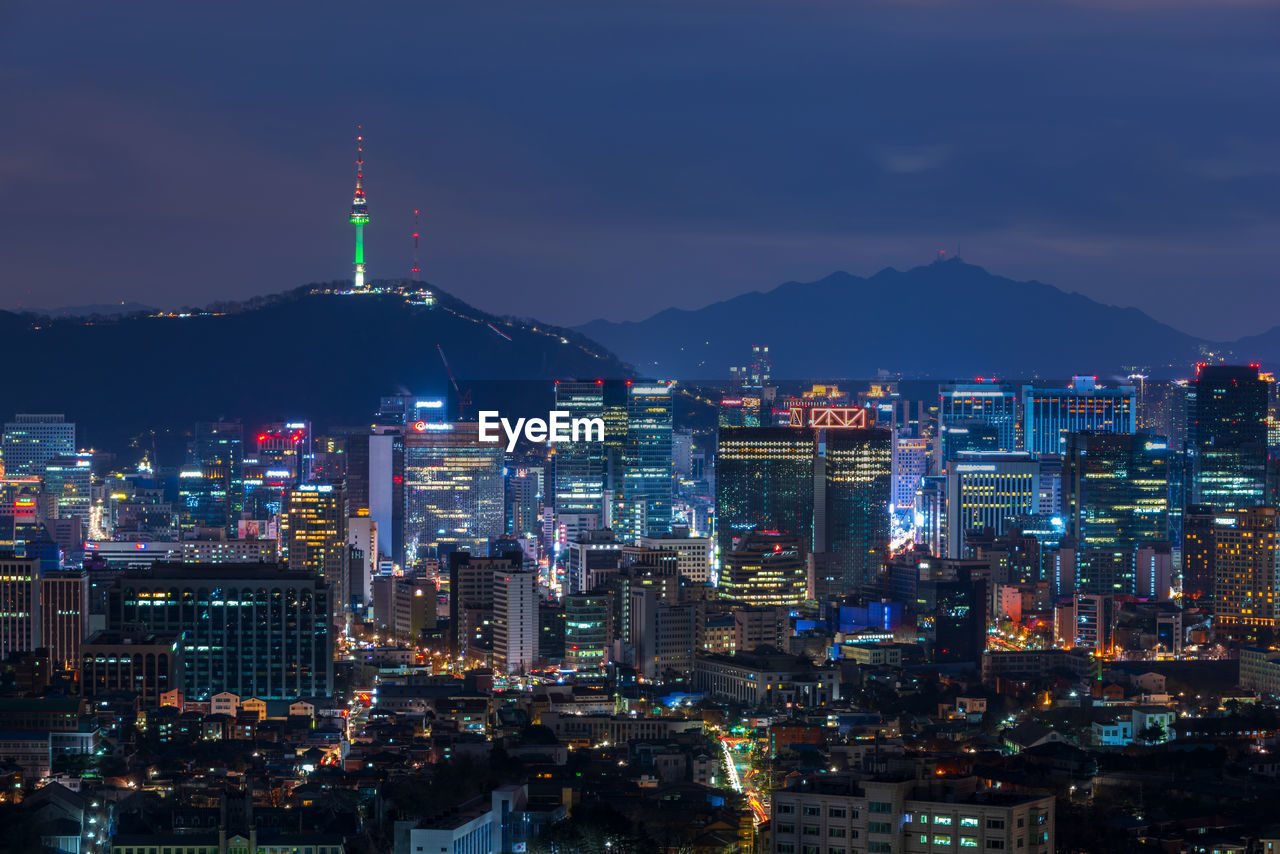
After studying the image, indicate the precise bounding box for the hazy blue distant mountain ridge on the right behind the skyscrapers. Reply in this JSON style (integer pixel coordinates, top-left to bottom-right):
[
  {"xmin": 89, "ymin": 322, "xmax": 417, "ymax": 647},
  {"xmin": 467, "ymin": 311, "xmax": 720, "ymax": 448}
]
[{"xmin": 577, "ymin": 260, "xmax": 1223, "ymax": 379}]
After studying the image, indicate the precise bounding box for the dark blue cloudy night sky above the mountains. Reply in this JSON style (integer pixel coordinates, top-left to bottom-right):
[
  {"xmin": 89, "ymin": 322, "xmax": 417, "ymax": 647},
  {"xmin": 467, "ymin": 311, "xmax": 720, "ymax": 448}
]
[{"xmin": 0, "ymin": 0, "xmax": 1280, "ymax": 338}]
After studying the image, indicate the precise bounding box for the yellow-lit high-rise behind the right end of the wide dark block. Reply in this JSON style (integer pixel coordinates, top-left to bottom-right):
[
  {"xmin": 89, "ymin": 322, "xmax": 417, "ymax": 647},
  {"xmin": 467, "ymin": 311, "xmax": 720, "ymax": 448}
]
[{"xmin": 280, "ymin": 484, "xmax": 351, "ymax": 618}]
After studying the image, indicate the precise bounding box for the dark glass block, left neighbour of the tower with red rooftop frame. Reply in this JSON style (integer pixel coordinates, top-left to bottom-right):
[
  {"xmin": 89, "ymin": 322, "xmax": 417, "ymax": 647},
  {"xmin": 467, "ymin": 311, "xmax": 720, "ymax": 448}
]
[{"xmin": 716, "ymin": 426, "xmax": 814, "ymax": 561}]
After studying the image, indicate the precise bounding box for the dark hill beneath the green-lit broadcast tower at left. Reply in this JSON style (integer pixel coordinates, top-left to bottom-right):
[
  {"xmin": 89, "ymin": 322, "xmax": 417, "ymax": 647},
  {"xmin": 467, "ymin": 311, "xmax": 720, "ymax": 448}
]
[{"xmin": 0, "ymin": 286, "xmax": 632, "ymax": 449}]
